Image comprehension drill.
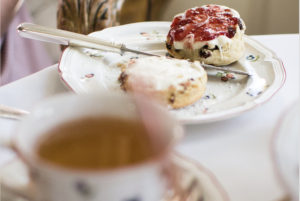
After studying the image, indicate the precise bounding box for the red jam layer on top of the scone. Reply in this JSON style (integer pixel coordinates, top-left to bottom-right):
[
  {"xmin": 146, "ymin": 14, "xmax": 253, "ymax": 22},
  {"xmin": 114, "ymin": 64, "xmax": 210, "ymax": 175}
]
[{"xmin": 168, "ymin": 5, "xmax": 243, "ymax": 45}]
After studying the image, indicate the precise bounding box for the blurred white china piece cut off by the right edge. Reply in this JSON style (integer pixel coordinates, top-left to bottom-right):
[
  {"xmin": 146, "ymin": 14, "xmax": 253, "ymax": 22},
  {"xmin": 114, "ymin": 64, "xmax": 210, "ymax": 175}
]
[{"xmin": 273, "ymin": 100, "xmax": 300, "ymax": 201}]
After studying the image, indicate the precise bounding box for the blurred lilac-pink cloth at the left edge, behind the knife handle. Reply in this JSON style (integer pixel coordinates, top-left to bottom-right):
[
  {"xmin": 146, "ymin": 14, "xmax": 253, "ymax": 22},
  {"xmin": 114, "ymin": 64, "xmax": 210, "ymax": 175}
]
[{"xmin": 0, "ymin": 5, "xmax": 54, "ymax": 85}]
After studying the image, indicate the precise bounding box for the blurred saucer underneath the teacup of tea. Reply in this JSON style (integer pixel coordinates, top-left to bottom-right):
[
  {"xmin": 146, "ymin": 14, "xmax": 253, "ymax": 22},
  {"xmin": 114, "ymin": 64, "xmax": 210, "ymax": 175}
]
[{"xmin": 0, "ymin": 154, "xmax": 229, "ymax": 201}]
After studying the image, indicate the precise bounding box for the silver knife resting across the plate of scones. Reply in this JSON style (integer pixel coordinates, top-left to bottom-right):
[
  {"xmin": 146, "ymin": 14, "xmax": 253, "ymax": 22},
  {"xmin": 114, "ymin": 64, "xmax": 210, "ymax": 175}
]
[{"xmin": 17, "ymin": 23, "xmax": 250, "ymax": 76}]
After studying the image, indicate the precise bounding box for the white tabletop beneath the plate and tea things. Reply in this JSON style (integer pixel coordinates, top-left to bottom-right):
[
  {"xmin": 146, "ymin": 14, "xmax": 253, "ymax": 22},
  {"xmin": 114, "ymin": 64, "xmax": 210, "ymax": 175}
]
[{"xmin": 0, "ymin": 34, "xmax": 300, "ymax": 201}]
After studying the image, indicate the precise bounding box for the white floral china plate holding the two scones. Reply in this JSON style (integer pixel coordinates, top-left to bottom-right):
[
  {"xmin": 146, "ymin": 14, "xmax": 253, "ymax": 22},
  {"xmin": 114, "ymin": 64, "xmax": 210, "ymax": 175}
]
[{"xmin": 59, "ymin": 22, "xmax": 285, "ymax": 123}]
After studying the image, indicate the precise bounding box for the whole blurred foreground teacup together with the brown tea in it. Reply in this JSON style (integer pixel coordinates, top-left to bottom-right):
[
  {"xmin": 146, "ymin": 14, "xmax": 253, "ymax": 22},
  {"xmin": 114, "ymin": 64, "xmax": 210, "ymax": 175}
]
[{"xmin": 10, "ymin": 93, "xmax": 183, "ymax": 201}]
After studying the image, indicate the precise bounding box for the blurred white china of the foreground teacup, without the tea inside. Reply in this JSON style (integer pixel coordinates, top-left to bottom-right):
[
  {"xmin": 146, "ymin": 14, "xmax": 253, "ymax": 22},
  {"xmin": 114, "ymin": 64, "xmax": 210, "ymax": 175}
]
[{"xmin": 5, "ymin": 93, "xmax": 183, "ymax": 201}]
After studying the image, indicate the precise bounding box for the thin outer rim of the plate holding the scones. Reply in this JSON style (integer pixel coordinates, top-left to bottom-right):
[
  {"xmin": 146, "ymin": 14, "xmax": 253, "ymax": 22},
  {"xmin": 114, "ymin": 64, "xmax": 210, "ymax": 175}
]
[{"xmin": 57, "ymin": 21, "xmax": 286, "ymax": 125}]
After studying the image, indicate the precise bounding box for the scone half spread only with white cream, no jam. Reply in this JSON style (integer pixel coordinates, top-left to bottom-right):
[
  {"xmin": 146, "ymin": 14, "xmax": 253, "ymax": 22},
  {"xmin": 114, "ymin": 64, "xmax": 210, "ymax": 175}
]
[{"xmin": 119, "ymin": 57, "xmax": 207, "ymax": 108}]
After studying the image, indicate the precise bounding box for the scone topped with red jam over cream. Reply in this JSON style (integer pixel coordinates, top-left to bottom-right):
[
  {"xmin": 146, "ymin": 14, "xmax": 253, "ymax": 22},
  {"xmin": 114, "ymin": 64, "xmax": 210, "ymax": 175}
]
[{"xmin": 166, "ymin": 5, "xmax": 246, "ymax": 66}]
